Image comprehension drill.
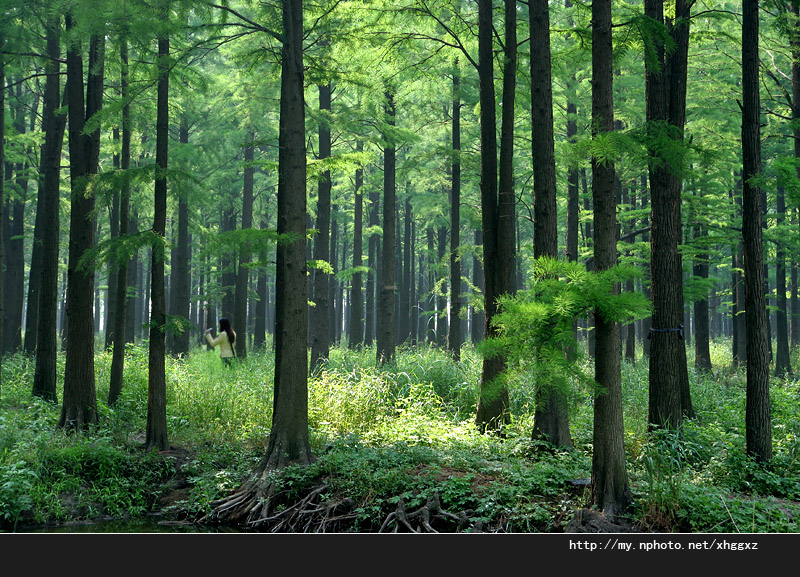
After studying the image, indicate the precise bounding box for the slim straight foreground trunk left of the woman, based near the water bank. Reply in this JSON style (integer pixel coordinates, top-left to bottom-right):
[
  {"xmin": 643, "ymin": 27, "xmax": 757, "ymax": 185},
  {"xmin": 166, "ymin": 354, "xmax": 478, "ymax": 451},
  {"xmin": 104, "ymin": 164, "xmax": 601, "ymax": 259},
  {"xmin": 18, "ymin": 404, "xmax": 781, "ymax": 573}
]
[{"xmin": 145, "ymin": 19, "xmax": 170, "ymax": 451}]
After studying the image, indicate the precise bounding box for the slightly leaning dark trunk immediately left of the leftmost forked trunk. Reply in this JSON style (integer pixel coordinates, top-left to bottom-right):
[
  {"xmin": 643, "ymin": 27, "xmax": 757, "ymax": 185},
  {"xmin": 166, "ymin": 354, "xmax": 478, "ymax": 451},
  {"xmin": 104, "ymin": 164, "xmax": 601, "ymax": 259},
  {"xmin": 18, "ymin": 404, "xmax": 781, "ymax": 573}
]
[{"xmin": 32, "ymin": 18, "xmax": 67, "ymax": 403}]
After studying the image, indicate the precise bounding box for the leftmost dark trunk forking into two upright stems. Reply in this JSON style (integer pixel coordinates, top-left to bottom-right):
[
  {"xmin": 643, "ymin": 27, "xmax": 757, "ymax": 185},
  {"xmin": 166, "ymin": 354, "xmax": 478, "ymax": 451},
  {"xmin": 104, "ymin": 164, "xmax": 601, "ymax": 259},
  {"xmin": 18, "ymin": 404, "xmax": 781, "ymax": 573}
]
[{"xmin": 58, "ymin": 19, "xmax": 104, "ymax": 430}]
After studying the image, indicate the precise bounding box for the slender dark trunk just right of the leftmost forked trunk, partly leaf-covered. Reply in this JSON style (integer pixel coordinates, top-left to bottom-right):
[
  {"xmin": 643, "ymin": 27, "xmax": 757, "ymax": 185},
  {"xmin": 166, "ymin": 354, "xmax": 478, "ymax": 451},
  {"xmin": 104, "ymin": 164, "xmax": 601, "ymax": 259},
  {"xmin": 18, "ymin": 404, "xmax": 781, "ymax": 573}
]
[{"xmin": 108, "ymin": 37, "xmax": 131, "ymax": 406}]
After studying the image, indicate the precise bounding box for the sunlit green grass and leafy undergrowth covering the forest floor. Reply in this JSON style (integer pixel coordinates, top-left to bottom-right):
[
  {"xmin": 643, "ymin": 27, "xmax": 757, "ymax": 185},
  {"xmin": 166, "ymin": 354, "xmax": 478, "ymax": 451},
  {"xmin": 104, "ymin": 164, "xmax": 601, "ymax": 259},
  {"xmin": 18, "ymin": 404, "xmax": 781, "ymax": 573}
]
[{"xmin": 0, "ymin": 342, "xmax": 800, "ymax": 533}]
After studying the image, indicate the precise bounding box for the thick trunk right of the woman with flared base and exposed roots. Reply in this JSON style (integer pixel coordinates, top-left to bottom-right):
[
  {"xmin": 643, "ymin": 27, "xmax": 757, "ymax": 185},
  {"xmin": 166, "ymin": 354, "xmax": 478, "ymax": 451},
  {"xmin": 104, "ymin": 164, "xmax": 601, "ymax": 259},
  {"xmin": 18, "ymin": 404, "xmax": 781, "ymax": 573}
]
[{"xmin": 209, "ymin": 0, "xmax": 313, "ymax": 524}]
